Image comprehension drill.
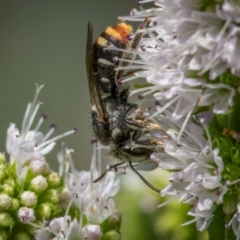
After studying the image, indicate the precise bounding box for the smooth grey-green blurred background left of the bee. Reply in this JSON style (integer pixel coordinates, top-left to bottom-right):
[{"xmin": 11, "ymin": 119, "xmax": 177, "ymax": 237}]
[{"xmin": 0, "ymin": 0, "xmax": 139, "ymax": 169}]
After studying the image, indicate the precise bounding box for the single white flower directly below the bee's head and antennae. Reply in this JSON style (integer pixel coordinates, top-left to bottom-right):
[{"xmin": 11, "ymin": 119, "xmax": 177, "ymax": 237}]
[{"xmin": 63, "ymin": 144, "xmax": 119, "ymax": 224}]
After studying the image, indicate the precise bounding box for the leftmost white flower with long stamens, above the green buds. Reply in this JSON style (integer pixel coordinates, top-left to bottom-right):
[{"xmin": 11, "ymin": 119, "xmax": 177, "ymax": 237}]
[{"xmin": 6, "ymin": 85, "xmax": 75, "ymax": 177}]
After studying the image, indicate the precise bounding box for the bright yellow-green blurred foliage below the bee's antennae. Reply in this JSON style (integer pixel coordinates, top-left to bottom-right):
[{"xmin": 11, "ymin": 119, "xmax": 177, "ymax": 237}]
[{"xmin": 115, "ymin": 170, "xmax": 208, "ymax": 240}]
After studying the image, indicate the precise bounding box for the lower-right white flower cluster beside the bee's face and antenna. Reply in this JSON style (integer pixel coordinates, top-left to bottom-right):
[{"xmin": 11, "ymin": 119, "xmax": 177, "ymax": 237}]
[{"xmin": 152, "ymin": 110, "xmax": 228, "ymax": 231}]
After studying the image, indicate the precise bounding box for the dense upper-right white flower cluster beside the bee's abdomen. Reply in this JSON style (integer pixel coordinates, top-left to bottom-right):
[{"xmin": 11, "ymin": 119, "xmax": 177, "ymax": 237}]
[{"xmin": 121, "ymin": 0, "xmax": 240, "ymax": 119}]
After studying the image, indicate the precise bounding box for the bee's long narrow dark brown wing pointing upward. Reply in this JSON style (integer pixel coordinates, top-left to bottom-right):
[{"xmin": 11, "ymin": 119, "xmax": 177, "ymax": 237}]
[{"xmin": 86, "ymin": 23, "xmax": 108, "ymax": 122}]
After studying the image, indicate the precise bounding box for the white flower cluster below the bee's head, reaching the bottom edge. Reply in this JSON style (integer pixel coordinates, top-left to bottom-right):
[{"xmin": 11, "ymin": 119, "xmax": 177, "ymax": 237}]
[{"xmin": 35, "ymin": 143, "xmax": 120, "ymax": 240}]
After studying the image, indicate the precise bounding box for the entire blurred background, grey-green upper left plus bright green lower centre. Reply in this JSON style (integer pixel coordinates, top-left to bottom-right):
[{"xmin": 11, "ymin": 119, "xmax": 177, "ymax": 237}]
[{"xmin": 0, "ymin": 0, "xmax": 206, "ymax": 240}]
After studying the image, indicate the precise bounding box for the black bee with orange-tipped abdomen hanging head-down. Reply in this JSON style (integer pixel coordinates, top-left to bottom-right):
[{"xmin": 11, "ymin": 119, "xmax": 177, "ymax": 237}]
[{"xmin": 86, "ymin": 20, "xmax": 162, "ymax": 192}]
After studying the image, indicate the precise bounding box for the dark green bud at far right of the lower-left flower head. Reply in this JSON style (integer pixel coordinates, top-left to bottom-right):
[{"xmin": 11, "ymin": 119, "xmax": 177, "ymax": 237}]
[{"xmin": 101, "ymin": 210, "xmax": 122, "ymax": 232}]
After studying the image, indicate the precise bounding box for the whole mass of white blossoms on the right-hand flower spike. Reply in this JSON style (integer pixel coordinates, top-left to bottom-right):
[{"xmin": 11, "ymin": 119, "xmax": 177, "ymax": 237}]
[{"xmin": 120, "ymin": 0, "xmax": 240, "ymax": 237}]
